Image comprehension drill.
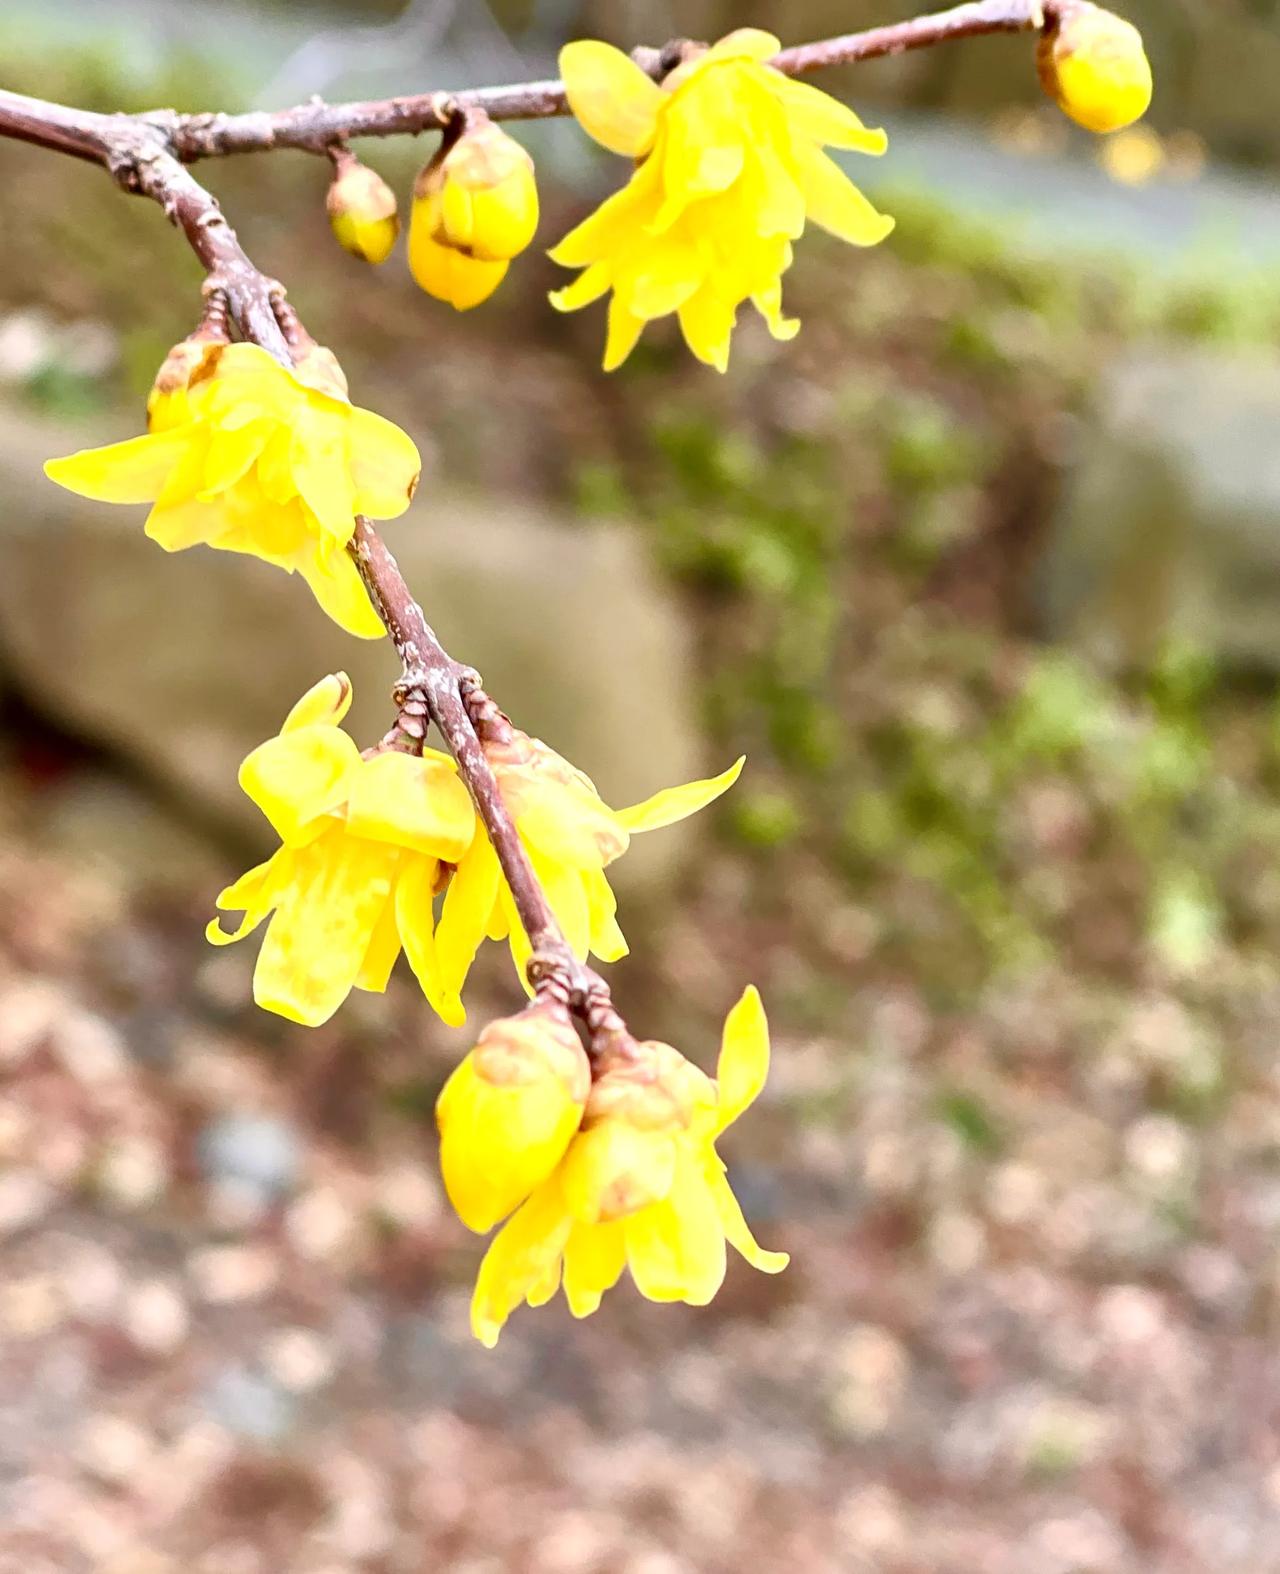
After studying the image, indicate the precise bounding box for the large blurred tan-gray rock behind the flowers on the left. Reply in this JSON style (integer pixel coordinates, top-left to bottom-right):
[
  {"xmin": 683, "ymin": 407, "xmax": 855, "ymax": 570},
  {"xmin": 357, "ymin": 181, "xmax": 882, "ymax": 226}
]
[{"xmin": 0, "ymin": 399, "xmax": 699, "ymax": 892}]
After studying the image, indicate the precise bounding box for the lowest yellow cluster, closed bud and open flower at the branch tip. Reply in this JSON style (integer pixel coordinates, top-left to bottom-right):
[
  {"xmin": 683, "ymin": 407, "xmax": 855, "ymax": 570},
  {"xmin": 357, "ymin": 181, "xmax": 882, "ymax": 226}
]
[{"xmin": 438, "ymin": 988, "xmax": 787, "ymax": 1346}]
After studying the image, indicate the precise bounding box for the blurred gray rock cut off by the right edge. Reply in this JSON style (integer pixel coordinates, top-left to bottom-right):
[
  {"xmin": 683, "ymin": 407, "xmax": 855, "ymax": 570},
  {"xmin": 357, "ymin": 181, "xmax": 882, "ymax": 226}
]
[{"xmin": 1036, "ymin": 349, "xmax": 1280, "ymax": 669}]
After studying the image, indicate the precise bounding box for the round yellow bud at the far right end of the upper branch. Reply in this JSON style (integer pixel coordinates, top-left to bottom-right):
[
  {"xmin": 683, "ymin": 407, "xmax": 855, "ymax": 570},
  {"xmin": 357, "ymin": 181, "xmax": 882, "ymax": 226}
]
[{"xmin": 1036, "ymin": 0, "xmax": 1152, "ymax": 132}]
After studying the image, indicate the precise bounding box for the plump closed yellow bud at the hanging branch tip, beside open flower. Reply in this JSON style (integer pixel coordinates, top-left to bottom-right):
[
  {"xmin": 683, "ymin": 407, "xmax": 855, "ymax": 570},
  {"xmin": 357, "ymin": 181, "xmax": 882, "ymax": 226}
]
[{"xmin": 436, "ymin": 1003, "xmax": 590, "ymax": 1234}]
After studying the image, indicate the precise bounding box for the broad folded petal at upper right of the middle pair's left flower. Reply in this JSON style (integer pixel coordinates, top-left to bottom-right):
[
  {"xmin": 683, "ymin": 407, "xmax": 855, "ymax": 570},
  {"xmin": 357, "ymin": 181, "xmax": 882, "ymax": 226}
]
[{"xmin": 346, "ymin": 751, "xmax": 475, "ymax": 864}]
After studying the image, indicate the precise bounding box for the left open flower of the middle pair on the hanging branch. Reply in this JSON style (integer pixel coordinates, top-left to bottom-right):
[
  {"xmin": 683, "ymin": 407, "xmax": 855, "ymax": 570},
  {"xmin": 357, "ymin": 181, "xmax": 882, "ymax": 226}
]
[{"xmin": 206, "ymin": 672, "xmax": 475, "ymax": 1028}]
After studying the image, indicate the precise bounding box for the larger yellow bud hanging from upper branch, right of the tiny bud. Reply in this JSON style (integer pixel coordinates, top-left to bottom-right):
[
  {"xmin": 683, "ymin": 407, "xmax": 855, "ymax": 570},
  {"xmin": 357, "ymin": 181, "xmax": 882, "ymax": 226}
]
[{"xmin": 409, "ymin": 120, "xmax": 538, "ymax": 312}]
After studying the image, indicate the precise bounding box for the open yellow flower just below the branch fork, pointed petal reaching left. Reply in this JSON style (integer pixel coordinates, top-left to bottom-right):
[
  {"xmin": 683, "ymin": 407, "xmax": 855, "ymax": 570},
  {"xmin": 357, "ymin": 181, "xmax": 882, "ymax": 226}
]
[{"xmin": 44, "ymin": 343, "xmax": 420, "ymax": 639}]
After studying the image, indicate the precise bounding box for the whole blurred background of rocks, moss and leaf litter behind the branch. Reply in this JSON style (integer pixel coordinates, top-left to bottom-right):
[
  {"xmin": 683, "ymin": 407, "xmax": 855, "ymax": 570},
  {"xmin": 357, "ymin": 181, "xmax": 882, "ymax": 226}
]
[{"xmin": 0, "ymin": 0, "xmax": 1280, "ymax": 1574}]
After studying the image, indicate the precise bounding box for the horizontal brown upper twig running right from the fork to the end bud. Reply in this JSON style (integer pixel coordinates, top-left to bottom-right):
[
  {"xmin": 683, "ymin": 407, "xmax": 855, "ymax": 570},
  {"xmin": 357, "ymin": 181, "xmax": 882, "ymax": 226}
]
[{"xmin": 167, "ymin": 0, "xmax": 1058, "ymax": 162}]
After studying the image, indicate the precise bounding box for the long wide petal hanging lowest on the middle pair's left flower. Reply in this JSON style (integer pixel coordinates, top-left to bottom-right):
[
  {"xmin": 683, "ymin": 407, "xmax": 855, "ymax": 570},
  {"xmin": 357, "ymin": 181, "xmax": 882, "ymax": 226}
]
[{"xmin": 253, "ymin": 826, "xmax": 400, "ymax": 1028}]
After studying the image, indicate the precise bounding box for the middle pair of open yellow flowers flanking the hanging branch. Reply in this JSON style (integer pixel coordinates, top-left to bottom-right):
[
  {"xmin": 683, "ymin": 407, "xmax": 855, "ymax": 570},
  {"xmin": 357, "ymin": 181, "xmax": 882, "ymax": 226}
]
[{"xmin": 208, "ymin": 674, "xmax": 743, "ymax": 1026}]
